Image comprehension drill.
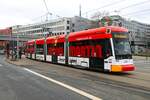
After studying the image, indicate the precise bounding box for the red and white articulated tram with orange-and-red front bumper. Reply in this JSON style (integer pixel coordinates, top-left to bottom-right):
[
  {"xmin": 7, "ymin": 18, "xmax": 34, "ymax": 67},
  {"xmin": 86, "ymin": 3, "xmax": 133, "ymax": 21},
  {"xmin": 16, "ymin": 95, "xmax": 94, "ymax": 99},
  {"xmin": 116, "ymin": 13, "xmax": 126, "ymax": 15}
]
[{"xmin": 27, "ymin": 26, "xmax": 135, "ymax": 72}]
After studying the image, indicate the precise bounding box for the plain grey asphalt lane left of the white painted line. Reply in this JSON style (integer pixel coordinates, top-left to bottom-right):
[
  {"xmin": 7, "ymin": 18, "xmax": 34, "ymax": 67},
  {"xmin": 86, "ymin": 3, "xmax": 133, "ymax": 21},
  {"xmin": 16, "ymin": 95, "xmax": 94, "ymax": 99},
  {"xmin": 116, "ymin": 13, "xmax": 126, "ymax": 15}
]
[{"xmin": 0, "ymin": 56, "xmax": 88, "ymax": 100}]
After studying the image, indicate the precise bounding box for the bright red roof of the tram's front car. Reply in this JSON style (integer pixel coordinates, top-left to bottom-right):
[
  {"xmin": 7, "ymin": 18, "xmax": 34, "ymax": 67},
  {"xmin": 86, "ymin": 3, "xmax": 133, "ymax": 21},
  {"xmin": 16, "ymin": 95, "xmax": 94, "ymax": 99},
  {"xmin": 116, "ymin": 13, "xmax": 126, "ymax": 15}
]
[{"xmin": 68, "ymin": 26, "xmax": 128, "ymax": 42}]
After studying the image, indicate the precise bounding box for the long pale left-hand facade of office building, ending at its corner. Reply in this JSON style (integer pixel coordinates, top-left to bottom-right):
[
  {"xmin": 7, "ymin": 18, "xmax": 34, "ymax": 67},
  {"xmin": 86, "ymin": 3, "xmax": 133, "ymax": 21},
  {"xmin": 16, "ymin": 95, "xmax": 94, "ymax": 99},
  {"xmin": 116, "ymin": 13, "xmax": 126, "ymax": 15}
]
[{"xmin": 12, "ymin": 18, "xmax": 70, "ymax": 39}]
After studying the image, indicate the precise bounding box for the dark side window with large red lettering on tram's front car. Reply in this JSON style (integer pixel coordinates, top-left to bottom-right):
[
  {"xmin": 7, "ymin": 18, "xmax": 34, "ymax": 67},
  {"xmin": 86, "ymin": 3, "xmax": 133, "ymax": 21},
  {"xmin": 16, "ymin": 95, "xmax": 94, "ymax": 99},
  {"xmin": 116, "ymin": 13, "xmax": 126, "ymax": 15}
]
[{"xmin": 69, "ymin": 40, "xmax": 102, "ymax": 58}]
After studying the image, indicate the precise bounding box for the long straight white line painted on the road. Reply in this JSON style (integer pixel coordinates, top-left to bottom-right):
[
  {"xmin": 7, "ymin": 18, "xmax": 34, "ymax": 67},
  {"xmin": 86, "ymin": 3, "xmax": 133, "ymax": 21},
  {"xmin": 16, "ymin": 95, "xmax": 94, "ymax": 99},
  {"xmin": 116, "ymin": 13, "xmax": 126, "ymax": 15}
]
[{"xmin": 24, "ymin": 68, "xmax": 102, "ymax": 100}]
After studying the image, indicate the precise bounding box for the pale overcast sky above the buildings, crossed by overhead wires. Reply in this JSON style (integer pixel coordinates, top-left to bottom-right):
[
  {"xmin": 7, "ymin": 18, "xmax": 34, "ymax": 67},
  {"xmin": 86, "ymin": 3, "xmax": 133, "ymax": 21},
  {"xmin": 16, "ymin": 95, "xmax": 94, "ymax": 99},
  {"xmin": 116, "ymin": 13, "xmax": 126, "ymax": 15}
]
[{"xmin": 0, "ymin": 0, "xmax": 150, "ymax": 28}]
